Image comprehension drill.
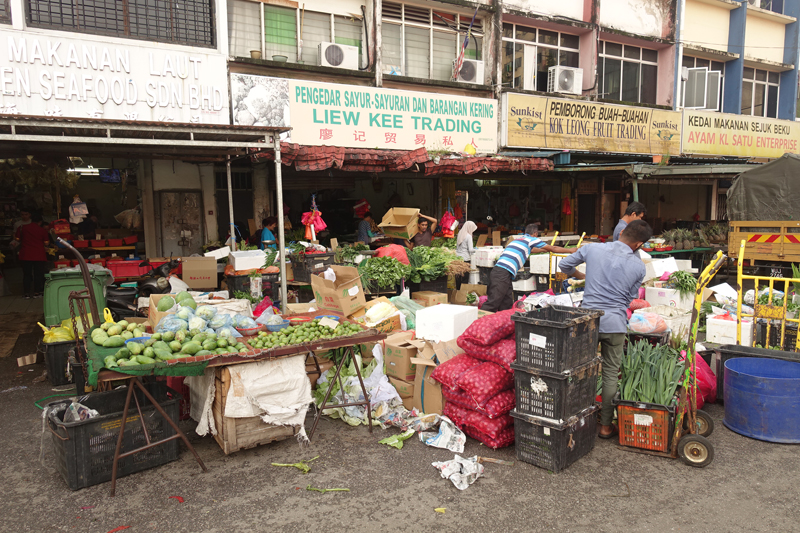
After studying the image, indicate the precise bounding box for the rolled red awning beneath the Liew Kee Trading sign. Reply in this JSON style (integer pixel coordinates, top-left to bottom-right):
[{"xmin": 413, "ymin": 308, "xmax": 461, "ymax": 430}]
[{"xmin": 251, "ymin": 143, "xmax": 553, "ymax": 176}]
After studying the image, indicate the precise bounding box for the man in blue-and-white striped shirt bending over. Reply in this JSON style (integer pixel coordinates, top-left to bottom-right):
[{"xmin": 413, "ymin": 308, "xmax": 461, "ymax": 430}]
[{"xmin": 481, "ymin": 224, "xmax": 574, "ymax": 313}]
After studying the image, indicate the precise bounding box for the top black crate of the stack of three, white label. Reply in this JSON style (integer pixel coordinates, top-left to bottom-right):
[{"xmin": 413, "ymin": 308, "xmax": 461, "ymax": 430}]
[{"xmin": 511, "ymin": 305, "xmax": 603, "ymax": 373}]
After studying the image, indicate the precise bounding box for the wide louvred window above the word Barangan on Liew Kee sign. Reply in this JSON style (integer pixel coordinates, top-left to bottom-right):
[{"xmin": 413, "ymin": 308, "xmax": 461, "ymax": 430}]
[{"xmin": 381, "ymin": 2, "xmax": 483, "ymax": 81}]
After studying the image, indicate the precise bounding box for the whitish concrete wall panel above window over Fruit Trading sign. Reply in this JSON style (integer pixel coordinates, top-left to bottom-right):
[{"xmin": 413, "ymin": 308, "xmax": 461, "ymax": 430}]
[{"xmin": 598, "ymin": 0, "xmax": 674, "ymax": 38}]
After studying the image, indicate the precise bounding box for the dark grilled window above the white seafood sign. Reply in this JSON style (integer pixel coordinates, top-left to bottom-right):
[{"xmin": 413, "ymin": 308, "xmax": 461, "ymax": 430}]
[{"xmin": 26, "ymin": 0, "xmax": 214, "ymax": 46}]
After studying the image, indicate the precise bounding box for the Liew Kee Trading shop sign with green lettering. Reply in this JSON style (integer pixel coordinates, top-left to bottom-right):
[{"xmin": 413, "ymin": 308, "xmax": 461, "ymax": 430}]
[{"xmin": 231, "ymin": 74, "xmax": 497, "ymax": 153}]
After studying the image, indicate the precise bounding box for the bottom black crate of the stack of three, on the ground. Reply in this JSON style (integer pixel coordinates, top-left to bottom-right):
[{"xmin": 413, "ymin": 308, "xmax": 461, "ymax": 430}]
[{"xmin": 511, "ymin": 406, "xmax": 598, "ymax": 472}]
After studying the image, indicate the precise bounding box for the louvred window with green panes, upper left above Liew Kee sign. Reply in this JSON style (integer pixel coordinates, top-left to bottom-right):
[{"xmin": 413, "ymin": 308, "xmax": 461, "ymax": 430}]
[{"xmin": 228, "ymin": 0, "xmax": 362, "ymax": 65}]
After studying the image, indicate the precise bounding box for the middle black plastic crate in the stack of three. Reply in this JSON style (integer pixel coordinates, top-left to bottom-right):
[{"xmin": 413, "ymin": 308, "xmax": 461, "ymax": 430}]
[{"xmin": 511, "ymin": 357, "xmax": 600, "ymax": 420}]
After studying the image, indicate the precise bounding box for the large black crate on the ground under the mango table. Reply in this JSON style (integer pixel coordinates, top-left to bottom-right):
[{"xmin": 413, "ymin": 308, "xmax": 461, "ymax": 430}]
[{"xmin": 47, "ymin": 382, "xmax": 181, "ymax": 490}]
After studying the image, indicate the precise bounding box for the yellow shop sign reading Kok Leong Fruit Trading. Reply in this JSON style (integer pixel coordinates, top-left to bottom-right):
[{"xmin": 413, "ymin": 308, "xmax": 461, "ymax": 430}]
[{"xmin": 502, "ymin": 93, "xmax": 681, "ymax": 155}]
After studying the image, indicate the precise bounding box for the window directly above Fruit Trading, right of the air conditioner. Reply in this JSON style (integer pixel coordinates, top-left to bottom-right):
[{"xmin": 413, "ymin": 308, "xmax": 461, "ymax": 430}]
[{"xmin": 599, "ymin": 41, "xmax": 658, "ymax": 104}]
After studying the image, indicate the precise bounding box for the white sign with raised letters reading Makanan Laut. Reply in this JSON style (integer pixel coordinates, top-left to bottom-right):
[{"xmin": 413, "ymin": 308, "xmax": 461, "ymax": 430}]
[{"xmin": 0, "ymin": 30, "xmax": 230, "ymax": 124}]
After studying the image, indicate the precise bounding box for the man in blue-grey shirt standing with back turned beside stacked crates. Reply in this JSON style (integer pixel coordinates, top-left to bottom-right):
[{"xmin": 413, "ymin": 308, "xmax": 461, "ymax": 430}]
[{"xmin": 559, "ymin": 220, "xmax": 653, "ymax": 439}]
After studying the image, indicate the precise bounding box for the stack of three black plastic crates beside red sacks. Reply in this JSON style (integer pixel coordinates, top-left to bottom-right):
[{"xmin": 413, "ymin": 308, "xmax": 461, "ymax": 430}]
[{"xmin": 511, "ymin": 306, "xmax": 603, "ymax": 472}]
